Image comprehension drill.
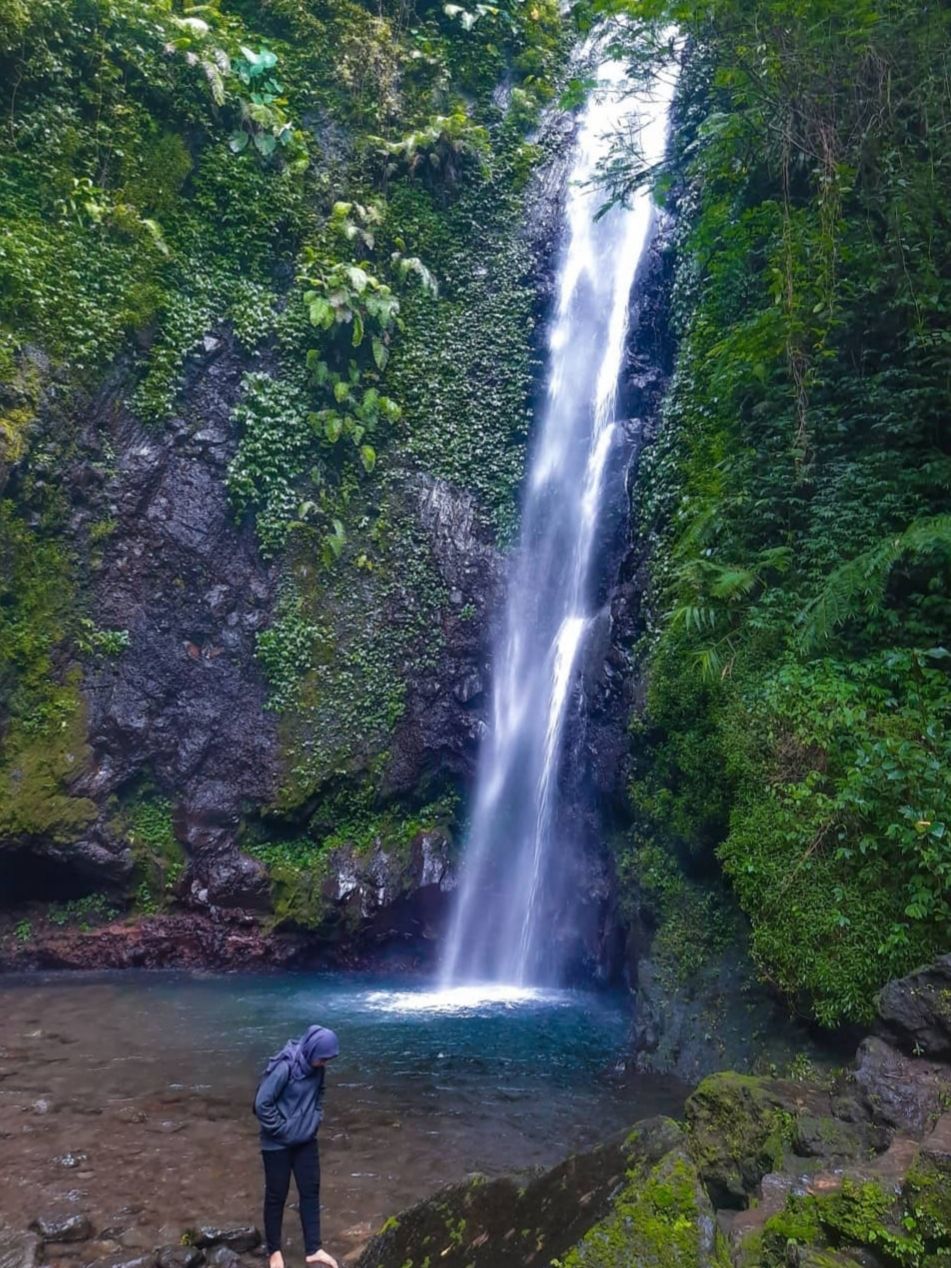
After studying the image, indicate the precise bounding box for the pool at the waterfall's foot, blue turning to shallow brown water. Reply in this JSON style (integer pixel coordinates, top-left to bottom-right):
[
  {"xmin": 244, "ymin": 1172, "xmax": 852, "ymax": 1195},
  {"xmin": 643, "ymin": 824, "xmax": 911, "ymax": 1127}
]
[{"xmin": 0, "ymin": 973, "xmax": 682, "ymax": 1258}]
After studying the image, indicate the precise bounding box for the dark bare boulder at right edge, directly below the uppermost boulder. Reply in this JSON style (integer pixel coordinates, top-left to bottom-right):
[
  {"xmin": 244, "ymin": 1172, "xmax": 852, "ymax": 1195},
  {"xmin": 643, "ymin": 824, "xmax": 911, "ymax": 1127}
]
[{"xmin": 855, "ymin": 1036, "xmax": 951, "ymax": 1137}]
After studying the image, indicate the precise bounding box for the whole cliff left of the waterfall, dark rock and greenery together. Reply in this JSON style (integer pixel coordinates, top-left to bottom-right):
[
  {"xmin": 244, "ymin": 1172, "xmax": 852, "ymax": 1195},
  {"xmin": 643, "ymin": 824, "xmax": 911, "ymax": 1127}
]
[{"xmin": 0, "ymin": 0, "xmax": 573, "ymax": 942}]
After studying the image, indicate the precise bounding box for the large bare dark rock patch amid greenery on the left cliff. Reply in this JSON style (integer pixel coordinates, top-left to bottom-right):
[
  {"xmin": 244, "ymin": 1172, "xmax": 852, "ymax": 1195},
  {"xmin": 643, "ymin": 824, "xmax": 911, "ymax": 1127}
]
[{"xmin": 70, "ymin": 337, "xmax": 279, "ymax": 905}]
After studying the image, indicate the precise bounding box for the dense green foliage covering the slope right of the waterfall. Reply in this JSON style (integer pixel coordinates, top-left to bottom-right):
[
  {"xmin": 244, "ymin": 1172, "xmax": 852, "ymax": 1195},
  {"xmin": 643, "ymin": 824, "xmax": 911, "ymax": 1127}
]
[{"xmin": 605, "ymin": 0, "xmax": 951, "ymax": 1025}]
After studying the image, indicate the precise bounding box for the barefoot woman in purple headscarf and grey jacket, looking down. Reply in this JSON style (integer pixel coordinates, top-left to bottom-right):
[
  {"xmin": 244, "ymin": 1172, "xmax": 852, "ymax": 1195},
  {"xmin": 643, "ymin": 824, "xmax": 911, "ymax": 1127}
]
[{"xmin": 255, "ymin": 1026, "xmax": 340, "ymax": 1268}]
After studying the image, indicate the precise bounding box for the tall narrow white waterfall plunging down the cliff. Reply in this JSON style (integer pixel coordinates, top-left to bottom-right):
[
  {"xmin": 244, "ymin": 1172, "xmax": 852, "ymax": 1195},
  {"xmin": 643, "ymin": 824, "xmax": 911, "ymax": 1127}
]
[{"xmin": 441, "ymin": 46, "xmax": 673, "ymax": 987}]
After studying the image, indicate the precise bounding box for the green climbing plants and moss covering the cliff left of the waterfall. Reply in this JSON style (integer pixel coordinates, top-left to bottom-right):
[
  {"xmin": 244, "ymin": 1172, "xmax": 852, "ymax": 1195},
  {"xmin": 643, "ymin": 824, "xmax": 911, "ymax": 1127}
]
[{"xmin": 0, "ymin": 0, "xmax": 569, "ymax": 877}]
